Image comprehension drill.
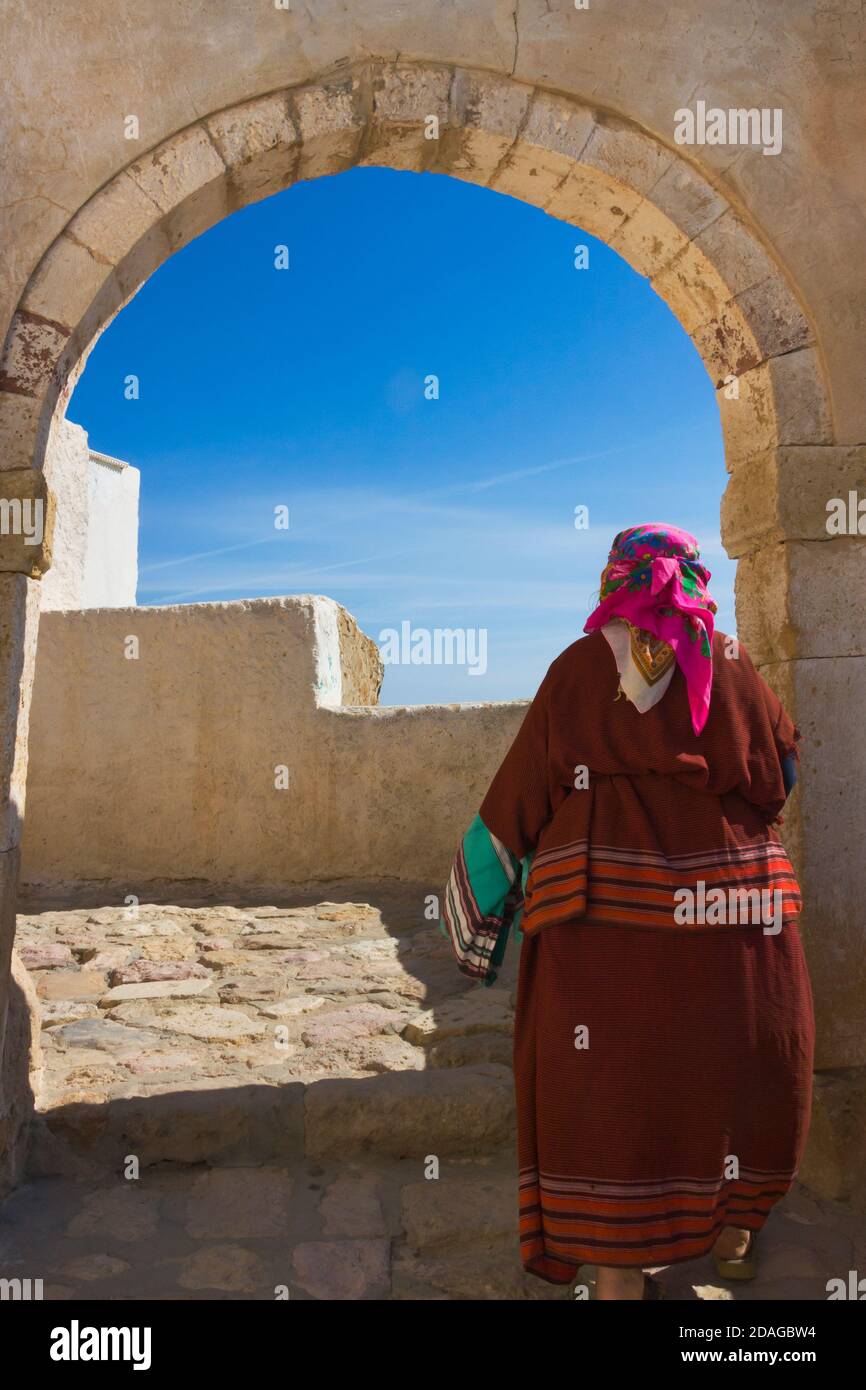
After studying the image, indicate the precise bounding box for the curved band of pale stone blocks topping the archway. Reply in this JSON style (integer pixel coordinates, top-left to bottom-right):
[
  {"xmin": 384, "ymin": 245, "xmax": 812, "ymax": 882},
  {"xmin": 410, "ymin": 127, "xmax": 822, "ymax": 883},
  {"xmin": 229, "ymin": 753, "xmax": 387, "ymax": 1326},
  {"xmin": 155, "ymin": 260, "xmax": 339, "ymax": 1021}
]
[{"xmin": 0, "ymin": 63, "xmax": 831, "ymax": 497}]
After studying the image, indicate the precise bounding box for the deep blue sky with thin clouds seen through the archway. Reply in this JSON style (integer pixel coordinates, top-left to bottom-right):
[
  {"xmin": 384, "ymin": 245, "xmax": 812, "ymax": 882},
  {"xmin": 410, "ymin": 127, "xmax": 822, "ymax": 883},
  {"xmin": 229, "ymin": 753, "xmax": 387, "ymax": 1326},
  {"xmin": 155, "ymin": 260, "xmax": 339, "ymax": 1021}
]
[{"xmin": 67, "ymin": 168, "xmax": 734, "ymax": 703}]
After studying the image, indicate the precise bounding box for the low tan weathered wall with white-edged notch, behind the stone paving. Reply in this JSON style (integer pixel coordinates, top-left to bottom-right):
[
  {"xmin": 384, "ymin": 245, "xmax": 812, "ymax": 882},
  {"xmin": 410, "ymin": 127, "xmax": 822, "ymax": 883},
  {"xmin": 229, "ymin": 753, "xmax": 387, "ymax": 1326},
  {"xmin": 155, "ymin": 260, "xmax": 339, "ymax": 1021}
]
[{"xmin": 22, "ymin": 598, "xmax": 524, "ymax": 898}]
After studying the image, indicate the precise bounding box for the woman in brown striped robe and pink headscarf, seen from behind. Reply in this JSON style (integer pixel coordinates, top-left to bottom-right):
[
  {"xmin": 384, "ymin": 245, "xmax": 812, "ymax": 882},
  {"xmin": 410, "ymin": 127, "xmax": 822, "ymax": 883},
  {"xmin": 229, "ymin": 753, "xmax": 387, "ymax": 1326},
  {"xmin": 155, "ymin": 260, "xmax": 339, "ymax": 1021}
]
[{"xmin": 442, "ymin": 523, "xmax": 815, "ymax": 1298}]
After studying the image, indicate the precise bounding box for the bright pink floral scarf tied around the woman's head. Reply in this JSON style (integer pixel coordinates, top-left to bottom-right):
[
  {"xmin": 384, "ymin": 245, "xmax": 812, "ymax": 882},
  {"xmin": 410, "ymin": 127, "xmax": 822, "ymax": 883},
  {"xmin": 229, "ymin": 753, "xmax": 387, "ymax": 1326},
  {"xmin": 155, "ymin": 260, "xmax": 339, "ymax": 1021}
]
[{"xmin": 584, "ymin": 521, "xmax": 716, "ymax": 734}]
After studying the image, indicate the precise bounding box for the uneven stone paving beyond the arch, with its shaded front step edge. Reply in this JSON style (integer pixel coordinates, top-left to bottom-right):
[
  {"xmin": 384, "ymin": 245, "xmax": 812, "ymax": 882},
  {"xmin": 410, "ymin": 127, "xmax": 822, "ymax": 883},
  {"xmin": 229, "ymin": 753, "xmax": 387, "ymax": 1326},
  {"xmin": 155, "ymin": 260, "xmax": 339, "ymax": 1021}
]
[{"xmin": 18, "ymin": 895, "xmax": 514, "ymax": 1176}]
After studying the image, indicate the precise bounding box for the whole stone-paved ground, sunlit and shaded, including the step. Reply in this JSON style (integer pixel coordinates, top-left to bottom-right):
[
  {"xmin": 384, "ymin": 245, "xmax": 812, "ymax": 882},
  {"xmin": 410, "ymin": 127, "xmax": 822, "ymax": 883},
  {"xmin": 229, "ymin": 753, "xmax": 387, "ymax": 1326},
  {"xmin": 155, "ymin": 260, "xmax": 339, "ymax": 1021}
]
[{"xmin": 0, "ymin": 884, "xmax": 866, "ymax": 1300}]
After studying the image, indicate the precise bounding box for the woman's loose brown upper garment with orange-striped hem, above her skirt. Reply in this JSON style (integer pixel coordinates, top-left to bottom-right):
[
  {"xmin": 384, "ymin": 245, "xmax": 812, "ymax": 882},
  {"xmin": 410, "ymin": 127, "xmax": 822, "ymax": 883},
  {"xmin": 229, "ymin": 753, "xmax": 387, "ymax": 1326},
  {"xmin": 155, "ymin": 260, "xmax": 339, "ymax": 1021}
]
[{"xmin": 480, "ymin": 632, "xmax": 801, "ymax": 934}]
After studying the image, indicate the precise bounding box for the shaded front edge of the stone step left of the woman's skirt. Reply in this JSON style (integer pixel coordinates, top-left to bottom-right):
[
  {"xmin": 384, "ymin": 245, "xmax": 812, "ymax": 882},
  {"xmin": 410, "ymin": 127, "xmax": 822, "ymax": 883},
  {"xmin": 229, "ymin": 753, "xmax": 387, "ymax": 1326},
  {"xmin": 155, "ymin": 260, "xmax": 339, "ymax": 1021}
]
[{"xmin": 28, "ymin": 1063, "xmax": 514, "ymax": 1177}]
